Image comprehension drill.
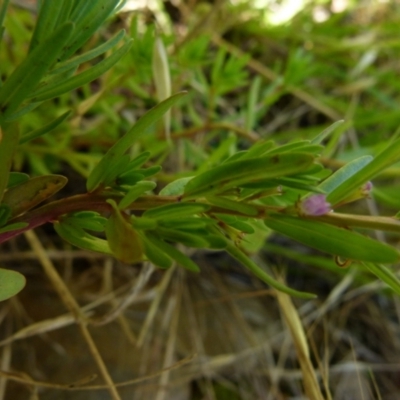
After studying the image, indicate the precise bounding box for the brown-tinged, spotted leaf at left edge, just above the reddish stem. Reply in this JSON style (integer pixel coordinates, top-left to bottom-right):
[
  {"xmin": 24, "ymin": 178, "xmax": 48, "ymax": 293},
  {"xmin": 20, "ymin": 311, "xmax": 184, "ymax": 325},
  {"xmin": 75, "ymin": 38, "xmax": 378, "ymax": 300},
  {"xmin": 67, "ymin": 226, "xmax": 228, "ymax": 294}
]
[{"xmin": 3, "ymin": 175, "xmax": 68, "ymax": 217}]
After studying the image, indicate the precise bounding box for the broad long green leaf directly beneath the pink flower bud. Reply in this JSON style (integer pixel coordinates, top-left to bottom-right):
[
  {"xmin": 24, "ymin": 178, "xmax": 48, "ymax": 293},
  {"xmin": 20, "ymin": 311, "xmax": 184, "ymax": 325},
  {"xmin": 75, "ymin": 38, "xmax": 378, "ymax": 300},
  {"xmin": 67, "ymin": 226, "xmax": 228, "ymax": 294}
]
[{"xmin": 264, "ymin": 214, "xmax": 400, "ymax": 263}]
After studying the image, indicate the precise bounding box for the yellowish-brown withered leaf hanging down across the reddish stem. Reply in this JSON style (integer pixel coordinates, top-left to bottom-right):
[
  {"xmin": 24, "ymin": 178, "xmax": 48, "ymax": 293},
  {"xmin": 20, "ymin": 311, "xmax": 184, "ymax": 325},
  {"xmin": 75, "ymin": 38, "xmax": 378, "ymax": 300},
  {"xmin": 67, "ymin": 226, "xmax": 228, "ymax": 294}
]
[{"xmin": 105, "ymin": 200, "xmax": 143, "ymax": 264}]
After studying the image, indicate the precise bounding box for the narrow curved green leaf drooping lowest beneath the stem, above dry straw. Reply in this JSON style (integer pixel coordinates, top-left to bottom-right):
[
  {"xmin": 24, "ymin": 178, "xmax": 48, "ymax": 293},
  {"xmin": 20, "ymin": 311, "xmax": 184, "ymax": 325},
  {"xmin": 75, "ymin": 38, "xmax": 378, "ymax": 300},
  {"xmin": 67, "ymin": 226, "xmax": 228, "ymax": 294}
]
[{"xmin": 226, "ymin": 239, "xmax": 316, "ymax": 299}]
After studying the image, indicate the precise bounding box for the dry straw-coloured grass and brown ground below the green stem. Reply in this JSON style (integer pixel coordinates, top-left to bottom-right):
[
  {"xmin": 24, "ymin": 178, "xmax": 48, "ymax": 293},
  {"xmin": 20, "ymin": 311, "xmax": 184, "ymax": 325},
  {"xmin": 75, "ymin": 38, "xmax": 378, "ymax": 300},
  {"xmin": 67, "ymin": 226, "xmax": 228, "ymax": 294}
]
[{"xmin": 0, "ymin": 228, "xmax": 400, "ymax": 400}]
